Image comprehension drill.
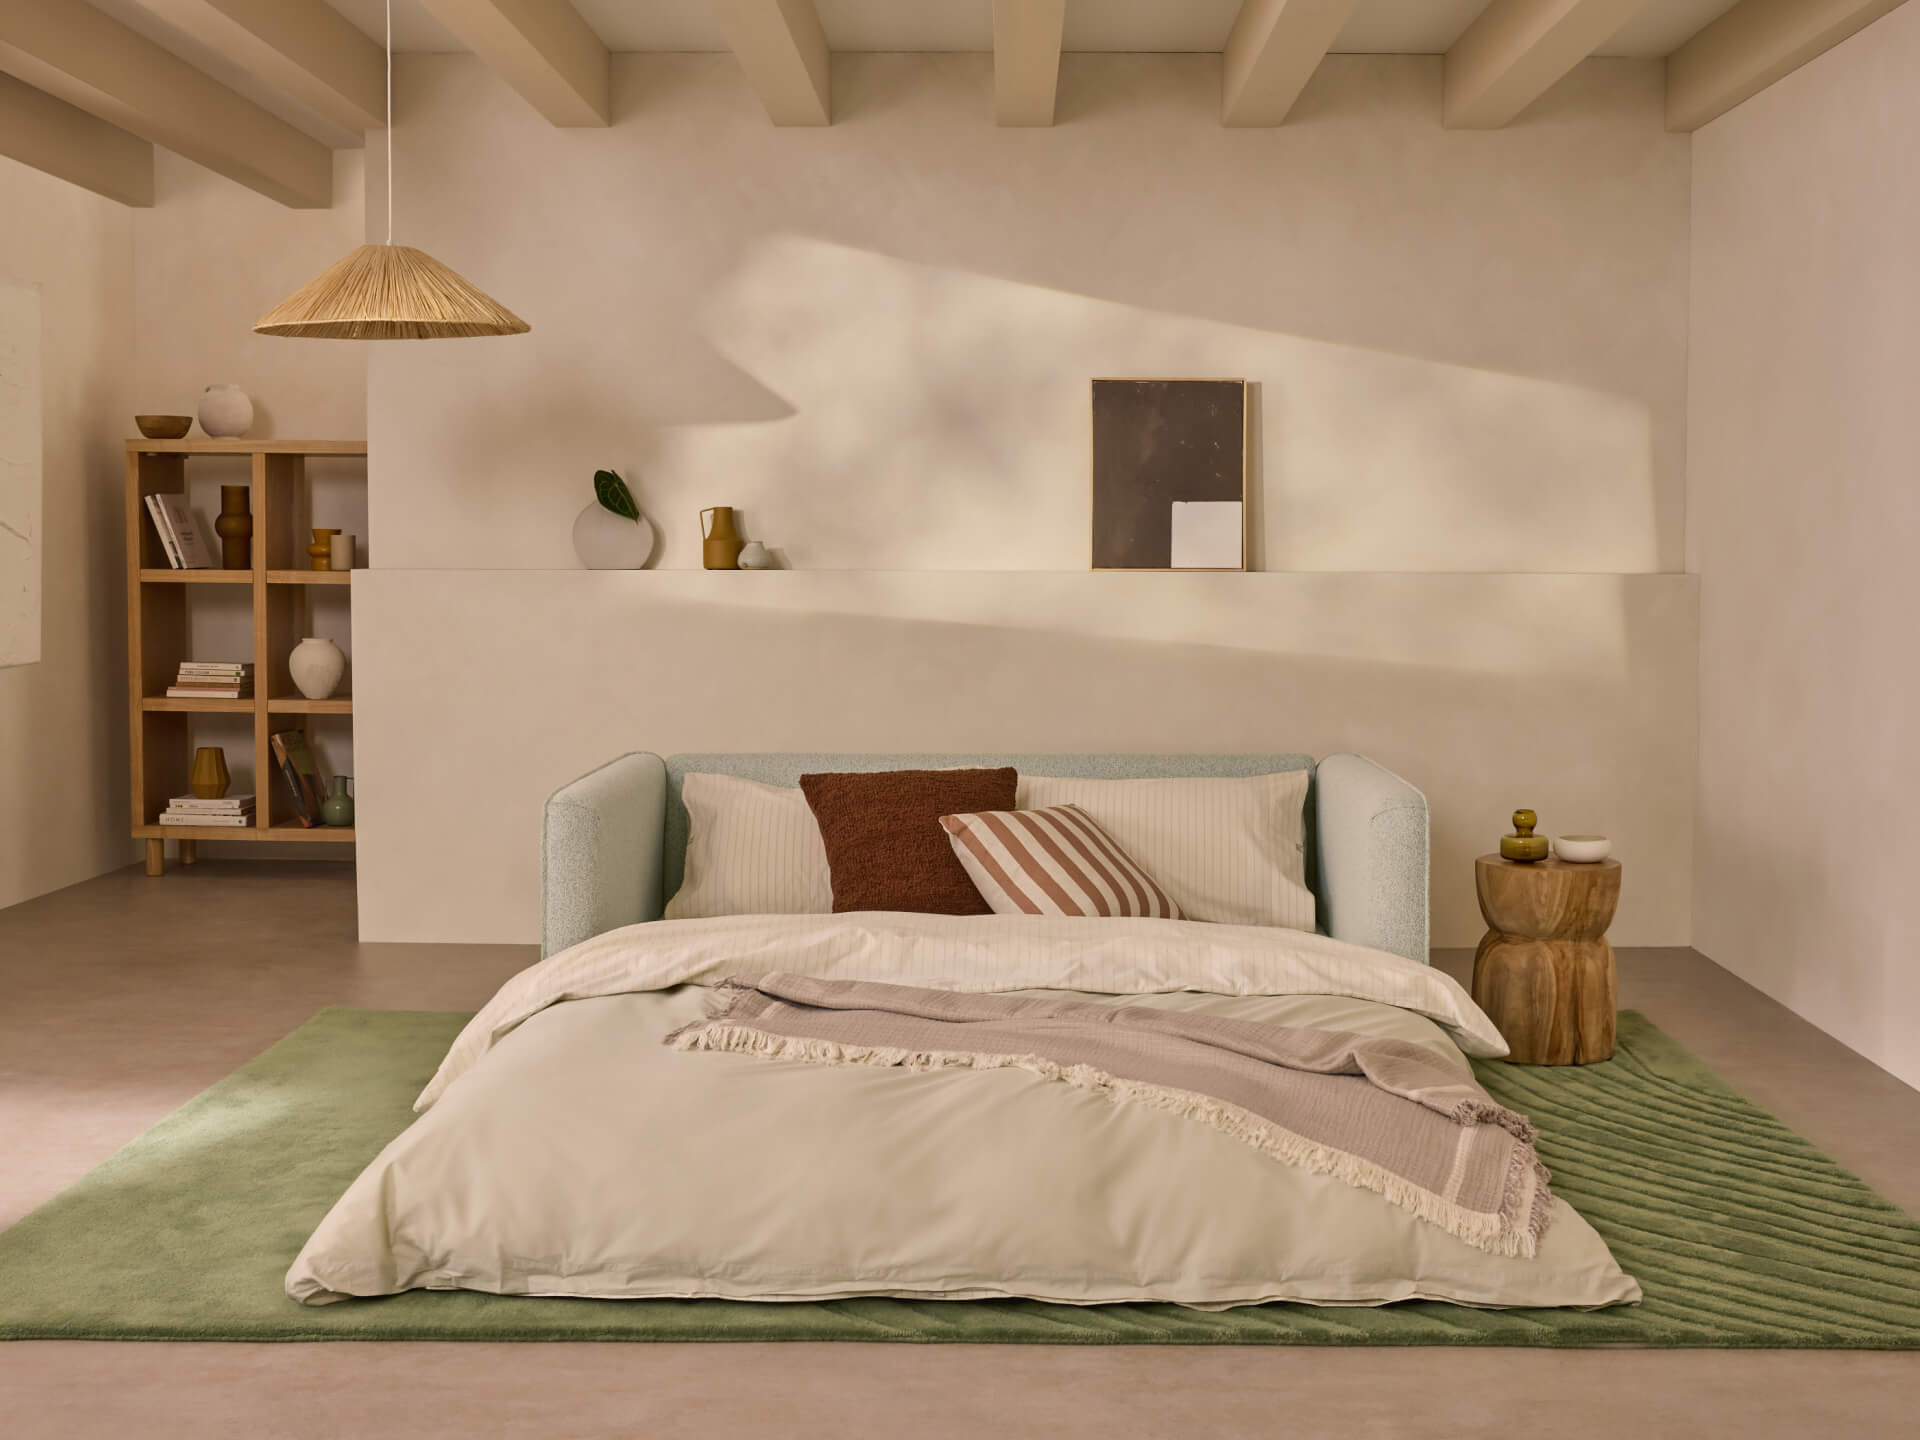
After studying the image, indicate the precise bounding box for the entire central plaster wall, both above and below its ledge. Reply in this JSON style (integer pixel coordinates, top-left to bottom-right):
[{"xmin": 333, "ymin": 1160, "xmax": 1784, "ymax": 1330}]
[{"xmin": 355, "ymin": 56, "xmax": 1693, "ymax": 945}]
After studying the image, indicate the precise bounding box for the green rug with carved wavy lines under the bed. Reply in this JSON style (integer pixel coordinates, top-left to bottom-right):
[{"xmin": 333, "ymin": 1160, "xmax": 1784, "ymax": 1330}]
[{"xmin": 0, "ymin": 1010, "xmax": 1920, "ymax": 1350}]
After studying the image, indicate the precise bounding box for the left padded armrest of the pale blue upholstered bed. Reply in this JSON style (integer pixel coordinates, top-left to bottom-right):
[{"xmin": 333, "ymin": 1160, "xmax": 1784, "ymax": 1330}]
[{"xmin": 540, "ymin": 751, "xmax": 666, "ymax": 956}]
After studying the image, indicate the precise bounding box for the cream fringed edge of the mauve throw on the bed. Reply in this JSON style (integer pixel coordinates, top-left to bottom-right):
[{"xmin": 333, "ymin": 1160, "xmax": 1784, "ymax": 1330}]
[{"xmin": 664, "ymin": 1013, "xmax": 1553, "ymax": 1260}]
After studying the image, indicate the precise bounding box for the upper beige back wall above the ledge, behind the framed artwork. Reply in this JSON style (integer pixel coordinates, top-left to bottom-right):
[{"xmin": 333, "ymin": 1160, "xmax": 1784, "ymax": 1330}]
[{"xmin": 369, "ymin": 56, "xmax": 1688, "ymax": 572}]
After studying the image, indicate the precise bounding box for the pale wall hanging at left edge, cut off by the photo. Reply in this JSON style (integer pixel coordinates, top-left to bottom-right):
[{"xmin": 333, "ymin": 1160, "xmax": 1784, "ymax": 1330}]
[{"xmin": 0, "ymin": 284, "xmax": 40, "ymax": 666}]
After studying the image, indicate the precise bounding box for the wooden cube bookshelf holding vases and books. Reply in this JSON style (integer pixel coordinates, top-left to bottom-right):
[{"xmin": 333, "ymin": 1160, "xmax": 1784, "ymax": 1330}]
[{"xmin": 127, "ymin": 440, "xmax": 367, "ymax": 876}]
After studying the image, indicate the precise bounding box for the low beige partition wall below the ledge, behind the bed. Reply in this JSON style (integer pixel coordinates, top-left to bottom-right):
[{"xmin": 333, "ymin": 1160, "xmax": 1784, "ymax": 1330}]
[{"xmin": 353, "ymin": 570, "xmax": 1697, "ymax": 947}]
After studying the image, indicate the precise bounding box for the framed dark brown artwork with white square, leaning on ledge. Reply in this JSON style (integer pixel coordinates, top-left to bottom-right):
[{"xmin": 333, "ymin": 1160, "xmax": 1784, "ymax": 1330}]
[{"xmin": 1092, "ymin": 380, "xmax": 1248, "ymax": 570}]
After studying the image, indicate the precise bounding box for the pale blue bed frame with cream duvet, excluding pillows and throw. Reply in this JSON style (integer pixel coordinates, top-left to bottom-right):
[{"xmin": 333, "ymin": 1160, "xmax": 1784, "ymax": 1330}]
[{"xmin": 288, "ymin": 755, "xmax": 1640, "ymax": 1308}]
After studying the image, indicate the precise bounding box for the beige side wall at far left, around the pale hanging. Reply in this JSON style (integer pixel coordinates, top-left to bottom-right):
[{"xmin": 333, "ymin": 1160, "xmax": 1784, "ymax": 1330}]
[{"xmin": 0, "ymin": 159, "xmax": 132, "ymax": 906}]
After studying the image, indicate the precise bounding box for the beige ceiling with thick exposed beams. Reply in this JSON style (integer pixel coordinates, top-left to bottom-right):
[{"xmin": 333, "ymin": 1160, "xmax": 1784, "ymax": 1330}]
[{"xmin": 0, "ymin": 0, "xmax": 1905, "ymax": 207}]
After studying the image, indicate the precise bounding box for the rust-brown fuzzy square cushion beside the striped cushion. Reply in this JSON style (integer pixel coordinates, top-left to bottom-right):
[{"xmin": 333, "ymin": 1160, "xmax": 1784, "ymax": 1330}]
[{"xmin": 801, "ymin": 766, "xmax": 1020, "ymax": 916}]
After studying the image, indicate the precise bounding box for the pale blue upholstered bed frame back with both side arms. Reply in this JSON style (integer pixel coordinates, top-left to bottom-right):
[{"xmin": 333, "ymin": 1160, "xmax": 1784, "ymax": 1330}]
[{"xmin": 540, "ymin": 751, "xmax": 1427, "ymax": 964}]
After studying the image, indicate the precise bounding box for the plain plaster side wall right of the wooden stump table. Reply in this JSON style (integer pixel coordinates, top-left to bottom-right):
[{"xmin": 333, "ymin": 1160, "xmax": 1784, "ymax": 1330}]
[{"xmin": 1688, "ymin": 6, "xmax": 1920, "ymax": 1085}]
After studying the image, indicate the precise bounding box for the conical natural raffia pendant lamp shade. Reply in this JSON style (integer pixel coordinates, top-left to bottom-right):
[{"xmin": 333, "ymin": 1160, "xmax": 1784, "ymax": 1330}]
[{"xmin": 253, "ymin": 246, "xmax": 532, "ymax": 340}]
